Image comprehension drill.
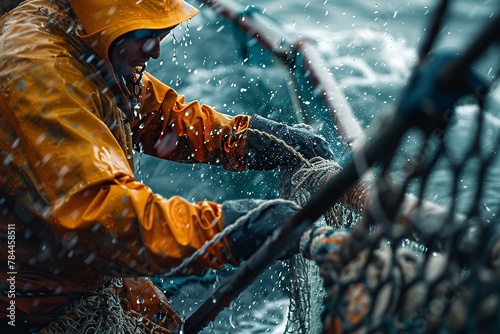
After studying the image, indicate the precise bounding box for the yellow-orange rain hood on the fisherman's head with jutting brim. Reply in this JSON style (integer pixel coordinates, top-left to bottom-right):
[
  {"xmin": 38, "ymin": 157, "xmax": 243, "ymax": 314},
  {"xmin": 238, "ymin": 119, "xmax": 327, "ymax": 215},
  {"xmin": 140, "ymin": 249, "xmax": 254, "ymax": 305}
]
[{"xmin": 69, "ymin": 0, "xmax": 198, "ymax": 61}]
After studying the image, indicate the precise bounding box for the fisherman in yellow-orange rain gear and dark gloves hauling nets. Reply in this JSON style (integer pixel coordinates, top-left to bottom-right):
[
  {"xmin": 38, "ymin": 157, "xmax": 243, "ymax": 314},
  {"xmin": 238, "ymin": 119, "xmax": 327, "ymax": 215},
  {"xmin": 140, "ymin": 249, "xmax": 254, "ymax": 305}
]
[{"xmin": 0, "ymin": 0, "xmax": 332, "ymax": 333}]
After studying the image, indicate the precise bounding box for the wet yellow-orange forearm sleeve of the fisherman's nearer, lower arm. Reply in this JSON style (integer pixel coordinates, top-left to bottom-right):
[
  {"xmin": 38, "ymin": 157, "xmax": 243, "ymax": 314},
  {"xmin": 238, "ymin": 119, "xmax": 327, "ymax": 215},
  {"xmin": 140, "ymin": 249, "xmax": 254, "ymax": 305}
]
[{"xmin": 53, "ymin": 176, "xmax": 235, "ymax": 275}]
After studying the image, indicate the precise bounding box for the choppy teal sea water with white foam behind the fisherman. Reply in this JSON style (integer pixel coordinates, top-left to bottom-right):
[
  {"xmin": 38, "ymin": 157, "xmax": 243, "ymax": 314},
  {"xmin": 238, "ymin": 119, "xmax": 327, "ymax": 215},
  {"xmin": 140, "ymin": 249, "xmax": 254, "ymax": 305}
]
[{"xmin": 136, "ymin": 0, "xmax": 500, "ymax": 333}]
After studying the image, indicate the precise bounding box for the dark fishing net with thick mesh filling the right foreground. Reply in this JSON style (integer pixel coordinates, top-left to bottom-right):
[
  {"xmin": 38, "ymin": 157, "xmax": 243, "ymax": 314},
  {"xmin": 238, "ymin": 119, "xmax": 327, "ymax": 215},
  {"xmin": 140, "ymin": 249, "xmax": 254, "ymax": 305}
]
[{"xmin": 281, "ymin": 54, "xmax": 500, "ymax": 333}]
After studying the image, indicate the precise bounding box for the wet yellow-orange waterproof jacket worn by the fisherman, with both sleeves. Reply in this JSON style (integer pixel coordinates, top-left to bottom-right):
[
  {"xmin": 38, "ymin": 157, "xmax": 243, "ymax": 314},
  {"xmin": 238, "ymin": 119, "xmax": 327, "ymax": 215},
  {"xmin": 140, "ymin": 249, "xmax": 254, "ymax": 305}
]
[{"xmin": 0, "ymin": 0, "xmax": 249, "ymax": 323}]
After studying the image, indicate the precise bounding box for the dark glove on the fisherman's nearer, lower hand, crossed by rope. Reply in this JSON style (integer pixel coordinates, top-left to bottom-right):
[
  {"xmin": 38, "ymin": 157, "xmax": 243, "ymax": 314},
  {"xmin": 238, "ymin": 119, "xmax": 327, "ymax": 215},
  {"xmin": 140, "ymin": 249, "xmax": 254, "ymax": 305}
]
[{"xmin": 222, "ymin": 199, "xmax": 299, "ymax": 262}]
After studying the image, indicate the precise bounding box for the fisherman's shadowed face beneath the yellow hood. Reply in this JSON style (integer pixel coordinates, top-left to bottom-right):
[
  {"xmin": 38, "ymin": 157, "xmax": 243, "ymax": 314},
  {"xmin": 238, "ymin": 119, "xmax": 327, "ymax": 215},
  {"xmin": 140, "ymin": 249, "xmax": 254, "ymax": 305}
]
[{"xmin": 110, "ymin": 33, "xmax": 166, "ymax": 75}]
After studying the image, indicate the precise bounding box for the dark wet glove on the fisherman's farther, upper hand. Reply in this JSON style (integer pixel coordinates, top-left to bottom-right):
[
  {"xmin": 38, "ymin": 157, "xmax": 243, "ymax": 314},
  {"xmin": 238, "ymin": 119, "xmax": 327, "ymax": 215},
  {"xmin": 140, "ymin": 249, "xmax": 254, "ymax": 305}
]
[{"xmin": 245, "ymin": 115, "xmax": 333, "ymax": 170}]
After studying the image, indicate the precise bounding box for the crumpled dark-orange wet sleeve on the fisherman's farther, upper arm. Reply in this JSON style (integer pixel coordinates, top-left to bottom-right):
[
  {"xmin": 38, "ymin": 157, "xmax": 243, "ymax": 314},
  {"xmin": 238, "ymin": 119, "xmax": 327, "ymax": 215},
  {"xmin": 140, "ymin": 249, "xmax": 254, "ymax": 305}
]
[{"xmin": 133, "ymin": 73, "xmax": 250, "ymax": 171}]
